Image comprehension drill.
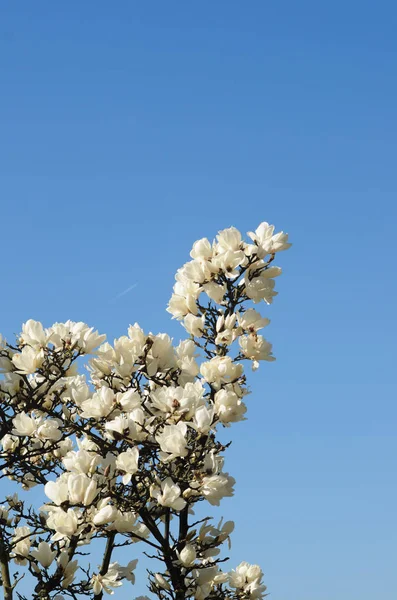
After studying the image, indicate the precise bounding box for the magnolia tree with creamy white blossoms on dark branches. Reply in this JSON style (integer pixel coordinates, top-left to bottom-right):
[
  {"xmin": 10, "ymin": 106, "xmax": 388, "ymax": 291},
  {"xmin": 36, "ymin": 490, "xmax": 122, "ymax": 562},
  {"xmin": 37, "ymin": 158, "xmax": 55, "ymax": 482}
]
[{"xmin": 0, "ymin": 223, "xmax": 290, "ymax": 600}]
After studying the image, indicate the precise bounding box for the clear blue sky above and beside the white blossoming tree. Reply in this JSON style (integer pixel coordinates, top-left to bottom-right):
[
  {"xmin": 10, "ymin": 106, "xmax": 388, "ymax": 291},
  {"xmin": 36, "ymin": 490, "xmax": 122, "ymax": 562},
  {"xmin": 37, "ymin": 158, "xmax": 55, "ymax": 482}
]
[{"xmin": 0, "ymin": 0, "xmax": 397, "ymax": 600}]
